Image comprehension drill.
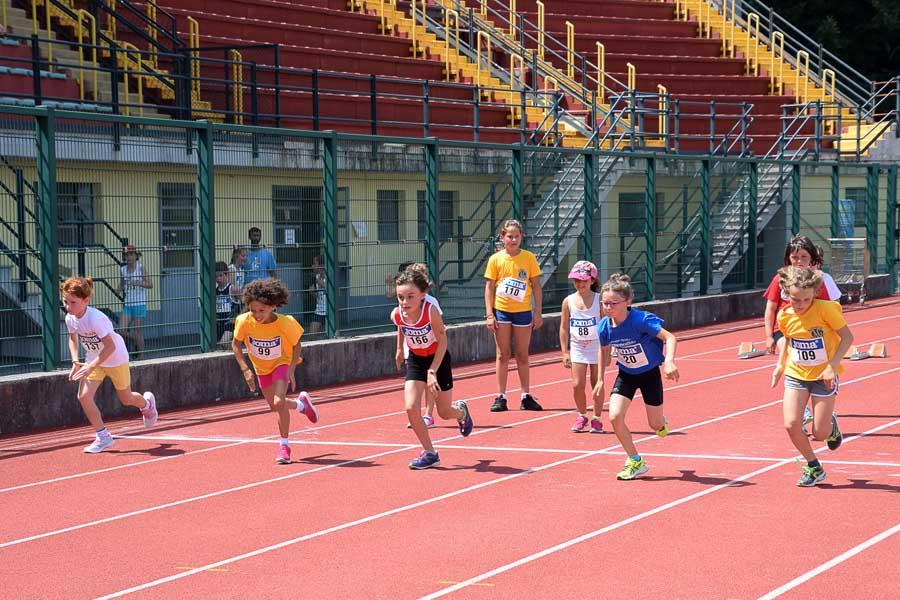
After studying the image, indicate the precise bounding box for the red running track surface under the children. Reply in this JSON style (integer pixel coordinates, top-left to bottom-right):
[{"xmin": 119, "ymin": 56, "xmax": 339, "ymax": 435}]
[{"xmin": 0, "ymin": 301, "xmax": 900, "ymax": 599}]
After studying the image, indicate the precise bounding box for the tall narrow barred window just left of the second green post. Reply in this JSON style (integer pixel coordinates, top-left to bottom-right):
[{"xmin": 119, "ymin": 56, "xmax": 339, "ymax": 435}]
[{"xmin": 156, "ymin": 182, "xmax": 197, "ymax": 270}]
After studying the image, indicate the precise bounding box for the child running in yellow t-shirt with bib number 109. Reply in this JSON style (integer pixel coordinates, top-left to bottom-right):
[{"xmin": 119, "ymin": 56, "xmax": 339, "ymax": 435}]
[{"xmin": 772, "ymin": 267, "xmax": 853, "ymax": 487}]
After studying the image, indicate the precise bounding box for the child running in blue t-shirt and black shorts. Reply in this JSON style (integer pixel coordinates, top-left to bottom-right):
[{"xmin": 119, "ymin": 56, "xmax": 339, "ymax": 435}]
[{"xmin": 594, "ymin": 273, "xmax": 678, "ymax": 479}]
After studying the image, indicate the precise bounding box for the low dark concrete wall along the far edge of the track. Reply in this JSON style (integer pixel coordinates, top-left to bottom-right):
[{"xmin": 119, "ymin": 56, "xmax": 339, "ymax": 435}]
[{"xmin": 0, "ymin": 276, "xmax": 889, "ymax": 434}]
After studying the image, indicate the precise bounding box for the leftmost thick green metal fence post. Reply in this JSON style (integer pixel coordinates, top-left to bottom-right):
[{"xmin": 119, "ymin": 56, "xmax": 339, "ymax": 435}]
[{"xmin": 35, "ymin": 109, "xmax": 60, "ymax": 371}]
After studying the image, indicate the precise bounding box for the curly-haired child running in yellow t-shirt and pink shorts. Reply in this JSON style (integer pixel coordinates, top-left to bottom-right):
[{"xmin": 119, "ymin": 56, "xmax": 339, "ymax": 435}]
[{"xmin": 231, "ymin": 279, "xmax": 319, "ymax": 465}]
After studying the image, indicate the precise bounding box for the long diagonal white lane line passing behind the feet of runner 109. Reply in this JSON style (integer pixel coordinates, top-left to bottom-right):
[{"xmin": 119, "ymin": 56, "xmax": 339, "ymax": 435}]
[{"xmin": 418, "ymin": 412, "xmax": 900, "ymax": 600}]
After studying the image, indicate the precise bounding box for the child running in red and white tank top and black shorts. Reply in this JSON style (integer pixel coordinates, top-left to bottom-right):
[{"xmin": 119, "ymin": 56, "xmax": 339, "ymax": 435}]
[{"xmin": 391, "ymin": 265, "xmax": 473, "ymax": 470}]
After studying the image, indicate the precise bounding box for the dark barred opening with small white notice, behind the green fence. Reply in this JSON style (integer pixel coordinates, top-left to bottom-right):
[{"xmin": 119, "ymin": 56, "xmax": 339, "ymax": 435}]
[{"xmin": 272, "ymin": 185, "xmax": 320, "ymax": 266}]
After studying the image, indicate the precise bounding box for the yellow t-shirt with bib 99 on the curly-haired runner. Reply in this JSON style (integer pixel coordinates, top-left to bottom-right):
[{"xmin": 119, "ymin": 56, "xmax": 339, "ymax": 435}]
[{"xmin": 234, "ymin": 312, "xmax": 303, "ymax": 375}]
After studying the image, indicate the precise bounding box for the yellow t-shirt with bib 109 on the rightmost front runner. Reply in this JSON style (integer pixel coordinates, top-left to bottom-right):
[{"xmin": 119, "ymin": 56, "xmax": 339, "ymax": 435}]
[{"xmin": 778, "ymin": 300, "xmax": 847, "ymax": 381}]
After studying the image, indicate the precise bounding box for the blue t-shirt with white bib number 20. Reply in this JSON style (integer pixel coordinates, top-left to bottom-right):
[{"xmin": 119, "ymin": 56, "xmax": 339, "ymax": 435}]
[{"xmin": 597, "ymin": 308, "xmax": 665, "ymax": 375}]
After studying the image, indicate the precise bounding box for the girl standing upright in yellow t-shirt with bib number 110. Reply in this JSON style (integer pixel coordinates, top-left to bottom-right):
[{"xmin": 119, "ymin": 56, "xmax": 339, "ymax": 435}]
[{"xmin": 484, "ymin": 219, "xmax": 543, "ymax": 412}]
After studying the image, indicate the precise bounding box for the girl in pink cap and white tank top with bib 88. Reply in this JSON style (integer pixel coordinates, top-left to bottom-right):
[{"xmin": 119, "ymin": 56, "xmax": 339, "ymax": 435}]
[{"xmin": 559, "ymin": 260, "xmax": 603, "ymax": 433}]
